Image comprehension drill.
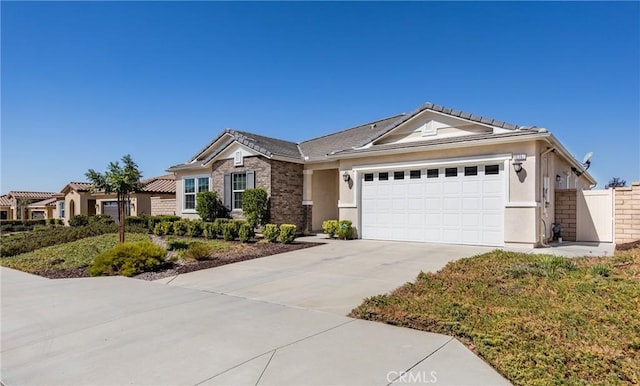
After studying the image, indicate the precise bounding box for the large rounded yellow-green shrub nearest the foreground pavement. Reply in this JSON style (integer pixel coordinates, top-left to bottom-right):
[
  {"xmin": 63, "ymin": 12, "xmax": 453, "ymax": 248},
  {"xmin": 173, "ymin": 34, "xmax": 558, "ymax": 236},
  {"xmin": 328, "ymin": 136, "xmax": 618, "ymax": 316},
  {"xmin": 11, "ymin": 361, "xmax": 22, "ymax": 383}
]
[{"xmin": 88, "ymin": 241, "xmax": 167, "ymax": 276}]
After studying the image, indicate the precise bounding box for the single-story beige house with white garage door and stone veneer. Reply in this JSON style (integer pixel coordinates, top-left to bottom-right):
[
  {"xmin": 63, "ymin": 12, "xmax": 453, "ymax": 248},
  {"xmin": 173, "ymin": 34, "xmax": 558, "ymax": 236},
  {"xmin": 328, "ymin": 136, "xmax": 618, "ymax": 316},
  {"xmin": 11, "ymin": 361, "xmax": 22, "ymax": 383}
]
[{"xmin": 167, "ymin": 103, "xmax": 596, "ymax": 246}]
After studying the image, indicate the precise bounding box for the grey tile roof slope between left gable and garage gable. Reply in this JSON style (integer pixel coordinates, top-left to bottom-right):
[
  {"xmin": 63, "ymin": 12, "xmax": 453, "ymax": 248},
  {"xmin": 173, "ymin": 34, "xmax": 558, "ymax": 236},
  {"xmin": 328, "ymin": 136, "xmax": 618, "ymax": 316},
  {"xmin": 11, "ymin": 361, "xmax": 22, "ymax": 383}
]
[{"xmin": 300, "ymin": 114, "xmax": 404, "ymax": 160}]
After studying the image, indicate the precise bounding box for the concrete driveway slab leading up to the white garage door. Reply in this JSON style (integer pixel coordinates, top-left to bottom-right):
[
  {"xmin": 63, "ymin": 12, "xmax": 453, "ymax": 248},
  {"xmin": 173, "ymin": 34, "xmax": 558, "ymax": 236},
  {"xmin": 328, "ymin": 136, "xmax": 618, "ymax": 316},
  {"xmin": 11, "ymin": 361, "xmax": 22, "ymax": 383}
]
[{"xmin": 160, "ymin": 237, "xmax": 495, "ymax": 315}]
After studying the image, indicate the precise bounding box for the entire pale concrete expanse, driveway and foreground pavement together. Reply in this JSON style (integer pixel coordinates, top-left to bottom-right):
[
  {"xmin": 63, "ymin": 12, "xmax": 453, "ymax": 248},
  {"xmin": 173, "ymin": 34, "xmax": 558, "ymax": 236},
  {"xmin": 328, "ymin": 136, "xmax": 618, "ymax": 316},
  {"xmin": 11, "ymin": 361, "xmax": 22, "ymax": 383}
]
[{"xmin": 0, "ymin": 241, "xmax": 508, "ymax": 386}]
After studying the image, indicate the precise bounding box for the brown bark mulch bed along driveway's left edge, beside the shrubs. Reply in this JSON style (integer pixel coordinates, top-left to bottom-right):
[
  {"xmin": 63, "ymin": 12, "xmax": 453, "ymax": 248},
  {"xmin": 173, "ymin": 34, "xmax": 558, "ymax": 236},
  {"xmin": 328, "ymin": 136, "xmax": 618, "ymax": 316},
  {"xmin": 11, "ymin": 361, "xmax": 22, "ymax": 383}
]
[{"xmin": 34, "ymin": 242, "xmax": 322, "ymax": 280}]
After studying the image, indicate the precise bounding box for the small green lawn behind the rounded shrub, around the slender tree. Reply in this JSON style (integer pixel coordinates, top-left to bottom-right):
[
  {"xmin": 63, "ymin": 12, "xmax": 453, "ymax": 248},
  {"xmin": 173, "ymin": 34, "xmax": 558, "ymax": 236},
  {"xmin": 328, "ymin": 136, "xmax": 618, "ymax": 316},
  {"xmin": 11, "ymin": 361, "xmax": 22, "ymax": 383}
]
[{"xmin": 0, "ymin": 233, "xmax": 149, "ymax": 272}]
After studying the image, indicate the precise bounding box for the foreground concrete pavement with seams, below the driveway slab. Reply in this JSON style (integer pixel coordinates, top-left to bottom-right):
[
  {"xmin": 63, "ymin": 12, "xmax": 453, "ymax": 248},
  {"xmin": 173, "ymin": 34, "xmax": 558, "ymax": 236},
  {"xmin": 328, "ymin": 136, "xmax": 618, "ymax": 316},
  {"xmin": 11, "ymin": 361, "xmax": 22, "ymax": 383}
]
[{"xmin": 0, "ymin": 260, "xmax": 508, "ymax": 386}]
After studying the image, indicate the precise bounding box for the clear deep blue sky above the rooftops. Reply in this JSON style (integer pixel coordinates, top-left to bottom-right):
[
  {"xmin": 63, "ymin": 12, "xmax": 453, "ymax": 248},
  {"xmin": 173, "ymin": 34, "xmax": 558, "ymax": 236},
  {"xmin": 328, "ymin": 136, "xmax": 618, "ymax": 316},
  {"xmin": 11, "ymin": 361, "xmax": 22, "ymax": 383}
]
[{"xmin": 0, "ymin": 1, "xmax": 640, "ymax": 193}]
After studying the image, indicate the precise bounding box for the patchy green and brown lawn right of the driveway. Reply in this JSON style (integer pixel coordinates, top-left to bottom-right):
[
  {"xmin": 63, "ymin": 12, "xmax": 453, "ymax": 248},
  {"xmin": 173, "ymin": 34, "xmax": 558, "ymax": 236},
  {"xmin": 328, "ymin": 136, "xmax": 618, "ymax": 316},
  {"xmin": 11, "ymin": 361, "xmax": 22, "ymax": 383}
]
[{"xmin": 351, "ymin": 248, "xmax": 640, "ymax": 385}]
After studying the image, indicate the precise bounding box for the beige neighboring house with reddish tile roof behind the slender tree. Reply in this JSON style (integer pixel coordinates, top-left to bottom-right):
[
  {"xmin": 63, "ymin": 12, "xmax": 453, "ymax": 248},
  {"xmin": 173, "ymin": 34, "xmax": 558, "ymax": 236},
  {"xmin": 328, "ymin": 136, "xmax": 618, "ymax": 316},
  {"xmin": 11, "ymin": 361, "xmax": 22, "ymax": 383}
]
[{"xmin": 55, "ymin": 174, "xmax": 176, "ymax": 224}]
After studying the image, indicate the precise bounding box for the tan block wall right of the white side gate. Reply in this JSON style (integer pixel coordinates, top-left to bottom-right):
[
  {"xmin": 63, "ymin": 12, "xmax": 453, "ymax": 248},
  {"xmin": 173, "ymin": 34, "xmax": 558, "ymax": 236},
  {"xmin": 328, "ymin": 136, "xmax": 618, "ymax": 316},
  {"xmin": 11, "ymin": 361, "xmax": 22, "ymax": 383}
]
[{"xmin": 614, "ymin": 182, "xmax": 640, "ymax": 244}]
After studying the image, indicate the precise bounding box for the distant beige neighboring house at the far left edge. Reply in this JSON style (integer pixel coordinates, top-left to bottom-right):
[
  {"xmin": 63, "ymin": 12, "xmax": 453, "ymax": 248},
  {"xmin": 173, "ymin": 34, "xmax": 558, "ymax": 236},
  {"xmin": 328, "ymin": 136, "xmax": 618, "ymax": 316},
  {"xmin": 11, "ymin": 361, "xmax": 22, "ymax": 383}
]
[{"xmin": 0, "ymin": 191, "xmax": 55, "ymax": 220}]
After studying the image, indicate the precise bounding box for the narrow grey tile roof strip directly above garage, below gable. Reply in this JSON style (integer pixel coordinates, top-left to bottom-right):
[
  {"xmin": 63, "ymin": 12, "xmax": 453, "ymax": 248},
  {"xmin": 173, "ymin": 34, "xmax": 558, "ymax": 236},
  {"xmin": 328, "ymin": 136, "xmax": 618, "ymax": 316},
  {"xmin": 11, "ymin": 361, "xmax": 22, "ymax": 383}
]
[{"xmin": 333, "ymin": 130, "xmax": 549, "ymax": 158}]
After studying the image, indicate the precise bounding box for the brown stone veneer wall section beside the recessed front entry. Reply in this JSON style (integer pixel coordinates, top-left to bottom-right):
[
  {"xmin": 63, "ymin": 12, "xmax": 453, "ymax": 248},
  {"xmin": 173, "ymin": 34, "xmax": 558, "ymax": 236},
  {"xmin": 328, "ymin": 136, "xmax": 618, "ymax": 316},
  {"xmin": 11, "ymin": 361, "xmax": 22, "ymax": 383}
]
[{"xmin": 271, "ymin": 160, "xmax": 305, "ymax": 232}]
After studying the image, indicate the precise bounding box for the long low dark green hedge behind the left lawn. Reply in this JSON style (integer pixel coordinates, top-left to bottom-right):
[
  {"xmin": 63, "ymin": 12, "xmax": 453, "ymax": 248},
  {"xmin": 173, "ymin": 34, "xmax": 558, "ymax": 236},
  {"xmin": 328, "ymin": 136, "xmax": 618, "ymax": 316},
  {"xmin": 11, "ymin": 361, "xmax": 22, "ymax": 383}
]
[{"xmin": 0, "ymin": 223, "xmax": 134, "ymax": 256}]
